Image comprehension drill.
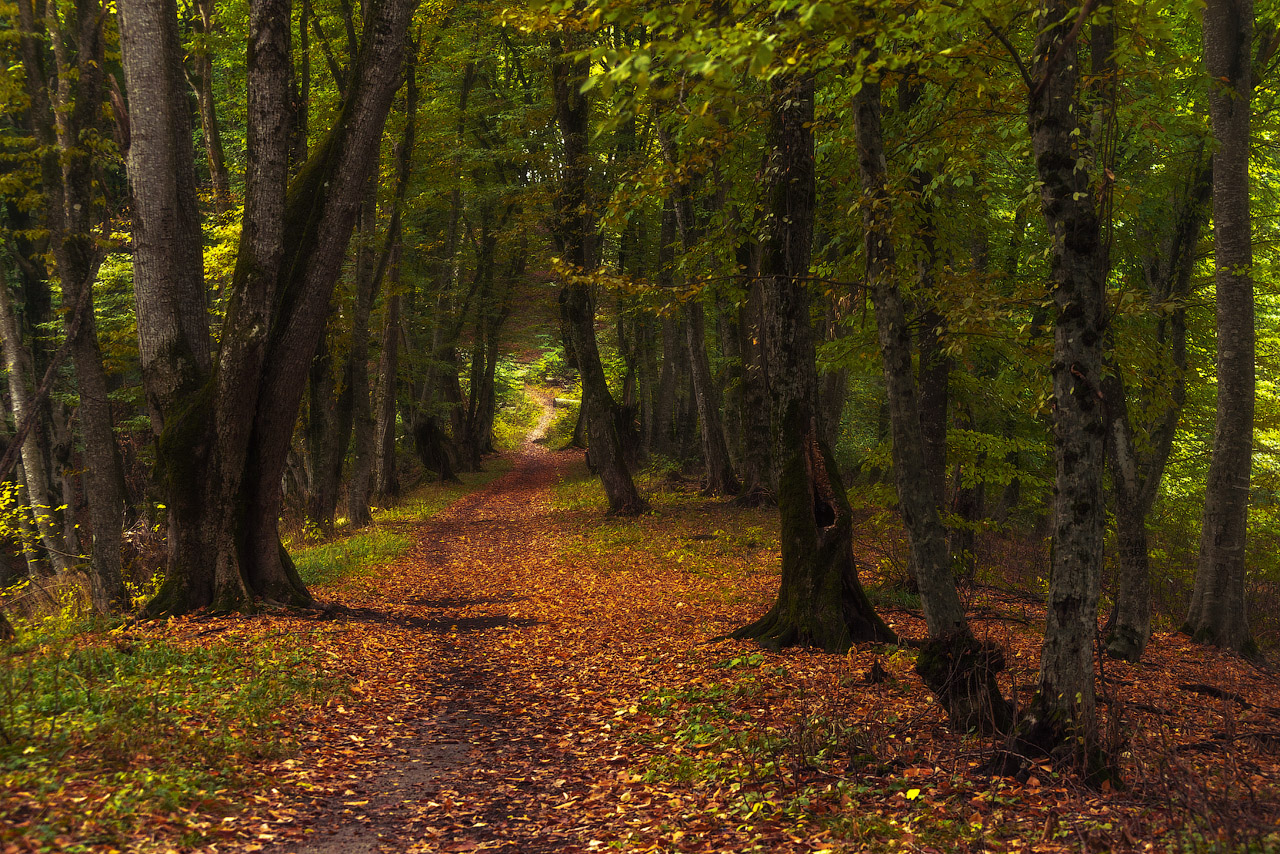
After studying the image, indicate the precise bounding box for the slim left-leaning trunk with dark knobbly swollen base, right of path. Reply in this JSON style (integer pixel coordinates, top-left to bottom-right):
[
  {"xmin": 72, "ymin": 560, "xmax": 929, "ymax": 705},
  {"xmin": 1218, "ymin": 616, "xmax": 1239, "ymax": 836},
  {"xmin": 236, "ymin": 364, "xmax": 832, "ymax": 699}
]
[{"xmin": 854, "ymin": 70, "xmax": 1012, "ymax": 731}]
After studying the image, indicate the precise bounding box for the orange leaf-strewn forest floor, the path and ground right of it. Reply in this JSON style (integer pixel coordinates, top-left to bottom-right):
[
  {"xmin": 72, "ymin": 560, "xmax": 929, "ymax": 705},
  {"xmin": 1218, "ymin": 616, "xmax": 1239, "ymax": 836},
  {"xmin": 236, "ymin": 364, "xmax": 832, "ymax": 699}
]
[{"xmin": 0, "ymin": 402, "xmax": 1280, "ymax": 854}]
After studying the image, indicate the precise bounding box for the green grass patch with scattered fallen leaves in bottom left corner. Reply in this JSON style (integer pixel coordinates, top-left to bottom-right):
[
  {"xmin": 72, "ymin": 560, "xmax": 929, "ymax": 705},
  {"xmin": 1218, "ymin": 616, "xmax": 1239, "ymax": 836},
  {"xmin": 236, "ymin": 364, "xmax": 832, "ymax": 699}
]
[{"xmin": 0, "ymin": 616, "xmax": 337, "ymax": 851}]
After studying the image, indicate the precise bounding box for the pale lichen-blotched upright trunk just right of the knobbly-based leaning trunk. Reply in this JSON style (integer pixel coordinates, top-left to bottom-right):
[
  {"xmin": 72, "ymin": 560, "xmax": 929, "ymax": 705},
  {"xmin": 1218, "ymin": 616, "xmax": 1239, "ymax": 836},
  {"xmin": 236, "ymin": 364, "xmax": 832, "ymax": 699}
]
[{"xmin": 1018, "ymin": 0, "xmax": 1106, "ymax": 772}]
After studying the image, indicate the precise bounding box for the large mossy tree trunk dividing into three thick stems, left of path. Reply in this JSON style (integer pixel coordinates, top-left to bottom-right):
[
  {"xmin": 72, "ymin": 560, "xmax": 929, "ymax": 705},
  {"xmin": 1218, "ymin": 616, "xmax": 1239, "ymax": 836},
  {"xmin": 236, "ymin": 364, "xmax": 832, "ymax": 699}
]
[{"xmin": 122, "ymin": 0, "xmax": 415, "ymax": 613}]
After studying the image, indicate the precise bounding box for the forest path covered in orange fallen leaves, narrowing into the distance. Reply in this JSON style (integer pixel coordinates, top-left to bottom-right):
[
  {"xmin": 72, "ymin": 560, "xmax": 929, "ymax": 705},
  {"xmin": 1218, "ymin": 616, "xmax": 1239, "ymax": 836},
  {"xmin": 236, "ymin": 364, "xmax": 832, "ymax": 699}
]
[{"xmin": 252, "ymin": 401, "xmax": 768, "ymax": 854}]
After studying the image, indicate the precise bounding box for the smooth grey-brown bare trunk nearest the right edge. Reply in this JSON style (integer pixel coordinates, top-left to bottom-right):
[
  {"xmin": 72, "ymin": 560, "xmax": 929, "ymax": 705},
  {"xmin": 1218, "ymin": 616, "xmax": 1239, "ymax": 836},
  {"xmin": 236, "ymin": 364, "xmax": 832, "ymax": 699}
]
[{"xmin": 1184, "ymin": 0, "xmax": 1257, "ymax": 653}]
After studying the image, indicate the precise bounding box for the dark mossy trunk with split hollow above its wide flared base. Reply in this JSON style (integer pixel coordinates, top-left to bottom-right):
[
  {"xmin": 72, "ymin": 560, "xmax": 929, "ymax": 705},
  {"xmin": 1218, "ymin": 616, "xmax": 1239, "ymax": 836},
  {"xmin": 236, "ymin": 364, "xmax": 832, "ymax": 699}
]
[{"xmin": 733, "ymin": 74, "xmax": 895, "ymax": 652}]
